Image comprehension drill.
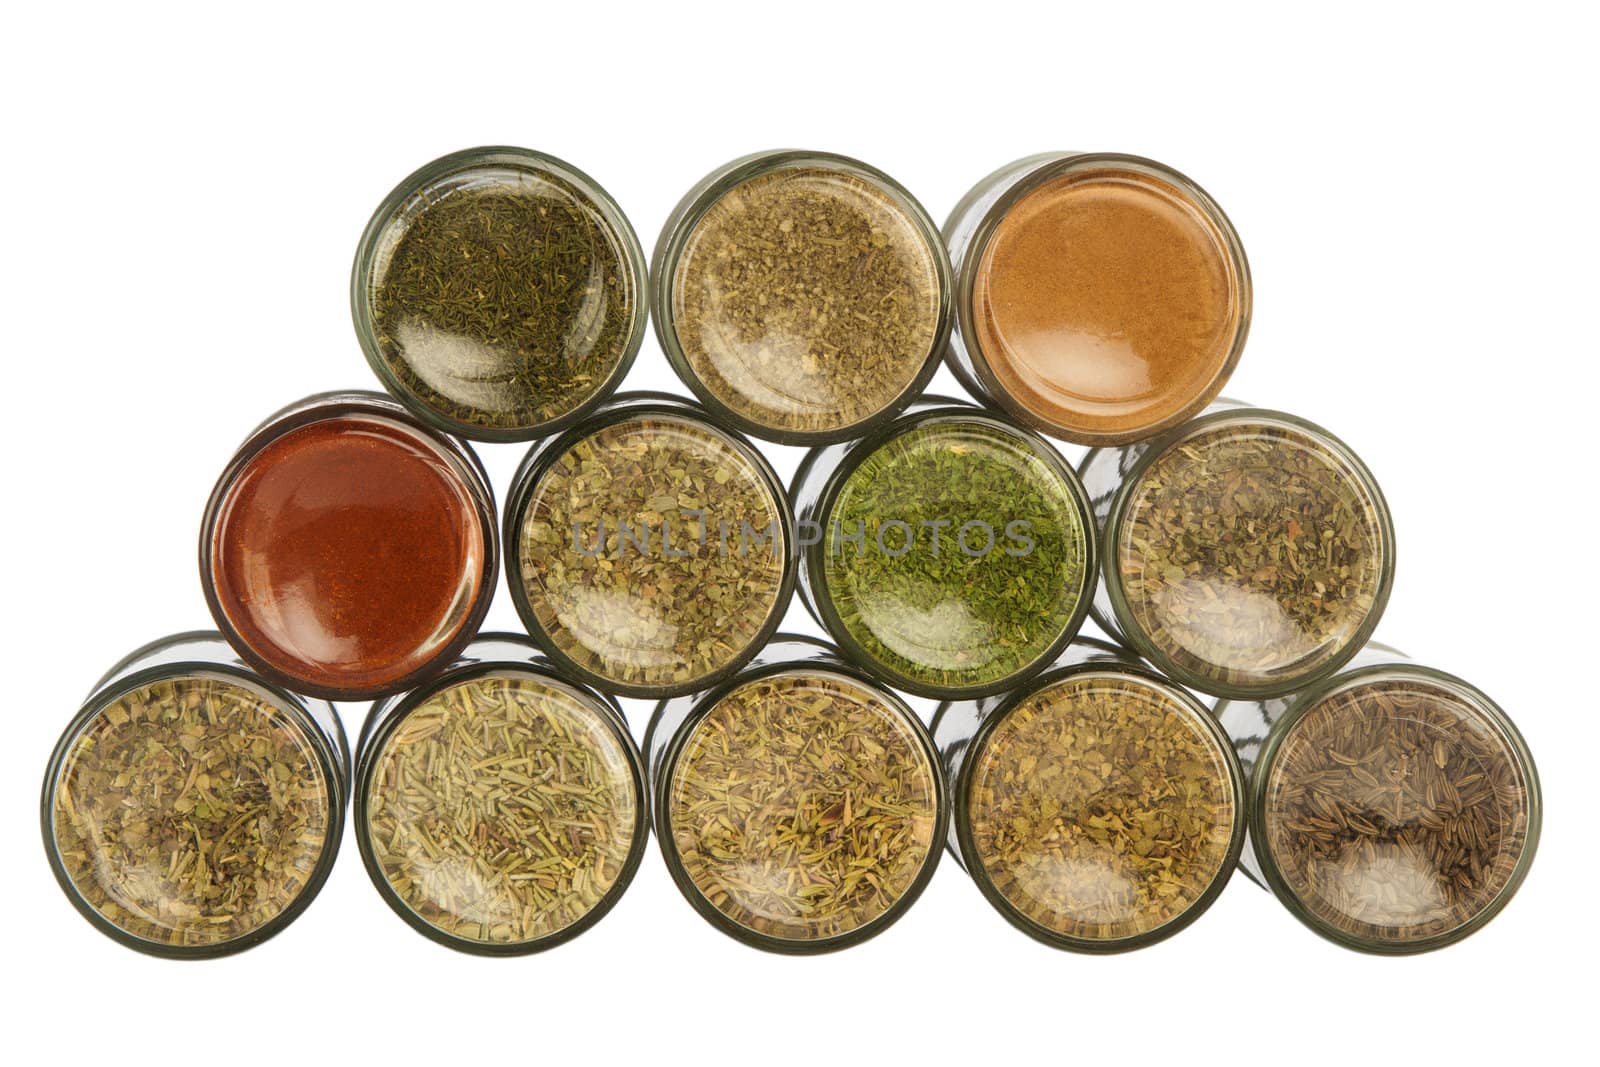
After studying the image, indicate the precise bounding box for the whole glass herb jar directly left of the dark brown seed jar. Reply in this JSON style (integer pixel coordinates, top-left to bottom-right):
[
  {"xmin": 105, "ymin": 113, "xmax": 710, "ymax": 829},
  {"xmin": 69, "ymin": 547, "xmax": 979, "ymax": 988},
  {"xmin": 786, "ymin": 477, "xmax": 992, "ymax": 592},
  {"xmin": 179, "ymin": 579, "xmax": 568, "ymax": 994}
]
[{"xmin": 933, "ymin": 637, "xmax": 1246, "ymax": 952}]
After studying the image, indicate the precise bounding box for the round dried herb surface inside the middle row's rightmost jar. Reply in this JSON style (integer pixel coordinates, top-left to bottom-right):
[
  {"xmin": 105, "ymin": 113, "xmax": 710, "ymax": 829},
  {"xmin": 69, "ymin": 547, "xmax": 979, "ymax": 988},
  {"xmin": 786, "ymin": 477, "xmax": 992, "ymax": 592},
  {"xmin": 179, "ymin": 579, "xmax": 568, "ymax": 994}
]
[{"xmin": 1115, "ymin": 419, "xmax": 1389, "ymax": 686}]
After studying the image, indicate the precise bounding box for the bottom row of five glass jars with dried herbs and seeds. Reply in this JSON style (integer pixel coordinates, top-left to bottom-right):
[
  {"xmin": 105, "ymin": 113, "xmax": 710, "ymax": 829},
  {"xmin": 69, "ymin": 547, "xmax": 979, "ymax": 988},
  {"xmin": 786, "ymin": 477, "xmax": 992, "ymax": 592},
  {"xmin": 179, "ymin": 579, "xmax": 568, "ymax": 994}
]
[{"xmin": 42, "ymin": 633, "xmax": 1541, "ymax": 957}]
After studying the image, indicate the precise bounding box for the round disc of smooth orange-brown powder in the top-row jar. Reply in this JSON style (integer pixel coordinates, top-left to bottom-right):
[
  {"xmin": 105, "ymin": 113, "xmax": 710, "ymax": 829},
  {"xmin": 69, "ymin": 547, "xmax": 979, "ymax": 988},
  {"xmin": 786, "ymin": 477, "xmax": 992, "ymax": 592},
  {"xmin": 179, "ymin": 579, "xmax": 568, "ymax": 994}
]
[{"xmin": 971, "ymin": 170, "xmax": 1245, "ymax": 443}]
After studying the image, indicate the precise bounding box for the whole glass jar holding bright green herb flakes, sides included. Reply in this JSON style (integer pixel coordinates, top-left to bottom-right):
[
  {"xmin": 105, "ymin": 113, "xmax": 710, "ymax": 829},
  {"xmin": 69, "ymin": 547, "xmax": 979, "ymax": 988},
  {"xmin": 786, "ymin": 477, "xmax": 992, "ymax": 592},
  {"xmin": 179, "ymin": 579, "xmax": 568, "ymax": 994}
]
[{"xmin": 790, "ymin": 397, "xmax": 1096, "ymax": 699}]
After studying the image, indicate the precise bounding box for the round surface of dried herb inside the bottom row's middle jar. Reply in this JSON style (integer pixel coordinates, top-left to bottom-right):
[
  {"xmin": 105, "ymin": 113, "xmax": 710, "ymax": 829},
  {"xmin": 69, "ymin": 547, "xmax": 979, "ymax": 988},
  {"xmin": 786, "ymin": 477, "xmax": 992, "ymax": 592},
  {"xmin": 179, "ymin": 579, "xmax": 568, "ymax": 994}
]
[{"xmin": 666, "ymin": 672, "xmax": 938, "ymax": 941}]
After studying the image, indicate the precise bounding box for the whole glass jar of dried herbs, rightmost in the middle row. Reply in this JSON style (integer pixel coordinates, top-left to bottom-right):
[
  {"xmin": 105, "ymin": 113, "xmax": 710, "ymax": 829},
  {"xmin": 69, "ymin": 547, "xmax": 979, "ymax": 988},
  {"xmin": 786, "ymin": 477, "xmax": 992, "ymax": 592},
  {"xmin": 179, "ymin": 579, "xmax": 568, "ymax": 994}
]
[{"xmin": 1078, "ymin": 402, "xmax": 1395, "ymax": 697}]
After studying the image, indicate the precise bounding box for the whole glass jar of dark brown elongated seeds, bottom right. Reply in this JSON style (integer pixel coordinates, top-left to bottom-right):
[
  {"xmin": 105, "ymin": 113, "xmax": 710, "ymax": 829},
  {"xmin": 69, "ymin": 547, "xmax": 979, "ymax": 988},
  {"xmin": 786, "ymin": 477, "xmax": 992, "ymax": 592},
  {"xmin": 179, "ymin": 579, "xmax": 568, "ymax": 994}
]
[{"xmin": 1216, "ymin": 641, "xmax": 1544, "ymax": 955}]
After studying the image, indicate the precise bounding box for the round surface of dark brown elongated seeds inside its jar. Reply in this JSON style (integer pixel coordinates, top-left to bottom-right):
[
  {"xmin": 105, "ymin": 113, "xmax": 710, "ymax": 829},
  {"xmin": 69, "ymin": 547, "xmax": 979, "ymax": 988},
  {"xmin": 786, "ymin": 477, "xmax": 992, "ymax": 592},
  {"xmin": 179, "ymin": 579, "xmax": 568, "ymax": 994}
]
[{"xmin": 1261, "ymin": 680, "xmax": 1533, "ymax": 942}]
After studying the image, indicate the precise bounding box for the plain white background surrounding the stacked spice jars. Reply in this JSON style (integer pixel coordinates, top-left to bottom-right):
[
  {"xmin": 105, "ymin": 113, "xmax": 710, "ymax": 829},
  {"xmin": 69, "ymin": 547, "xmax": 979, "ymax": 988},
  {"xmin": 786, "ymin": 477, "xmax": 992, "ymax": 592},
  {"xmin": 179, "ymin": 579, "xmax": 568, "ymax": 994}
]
[{"xmin": 0, "ymin": 0, "xmax": 1600, "ymax": 1067}]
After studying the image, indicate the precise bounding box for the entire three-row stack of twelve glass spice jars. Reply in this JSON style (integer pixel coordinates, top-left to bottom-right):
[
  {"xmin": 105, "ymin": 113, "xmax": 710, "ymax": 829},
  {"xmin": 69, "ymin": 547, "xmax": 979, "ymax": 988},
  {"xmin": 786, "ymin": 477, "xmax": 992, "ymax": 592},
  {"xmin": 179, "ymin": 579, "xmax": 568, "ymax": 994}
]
[{"xmin": 42, "ymin": 147, "xmax": 1541, "ymax": 958}]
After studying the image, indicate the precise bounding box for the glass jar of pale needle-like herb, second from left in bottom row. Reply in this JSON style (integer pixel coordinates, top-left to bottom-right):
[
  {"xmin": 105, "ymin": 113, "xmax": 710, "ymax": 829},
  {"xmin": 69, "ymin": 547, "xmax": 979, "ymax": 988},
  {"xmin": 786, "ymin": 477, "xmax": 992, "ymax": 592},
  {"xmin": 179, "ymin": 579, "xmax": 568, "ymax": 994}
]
[{"xmin": 355, "ymin": 633, "xmax": 650, "ymax": 955}]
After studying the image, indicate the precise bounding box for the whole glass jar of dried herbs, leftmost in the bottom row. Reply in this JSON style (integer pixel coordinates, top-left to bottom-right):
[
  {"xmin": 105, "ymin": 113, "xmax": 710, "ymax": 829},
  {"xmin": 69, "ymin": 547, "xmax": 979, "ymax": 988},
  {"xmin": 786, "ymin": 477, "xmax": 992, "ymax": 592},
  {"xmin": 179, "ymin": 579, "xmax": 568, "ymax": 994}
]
[{"xmin": 40, "ymin": 632, "xmax": 350, "ymax": 960}]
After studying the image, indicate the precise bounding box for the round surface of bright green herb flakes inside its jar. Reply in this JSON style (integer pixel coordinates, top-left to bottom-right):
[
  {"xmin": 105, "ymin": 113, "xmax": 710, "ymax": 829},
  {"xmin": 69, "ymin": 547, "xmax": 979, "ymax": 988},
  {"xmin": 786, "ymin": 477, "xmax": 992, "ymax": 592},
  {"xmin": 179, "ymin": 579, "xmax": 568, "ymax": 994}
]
[{"xmin": 822, "ymin": 419, "xmax": 1088, "ymax": 686}]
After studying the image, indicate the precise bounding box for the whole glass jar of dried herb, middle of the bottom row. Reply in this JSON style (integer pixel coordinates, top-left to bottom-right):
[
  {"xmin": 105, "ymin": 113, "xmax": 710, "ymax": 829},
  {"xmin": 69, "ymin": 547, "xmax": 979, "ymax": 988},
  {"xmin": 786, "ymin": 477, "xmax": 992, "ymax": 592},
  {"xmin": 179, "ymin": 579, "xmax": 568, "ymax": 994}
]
[{"xmin": 645, "ymin": 635, "xmax": 949, "ymax": 953}]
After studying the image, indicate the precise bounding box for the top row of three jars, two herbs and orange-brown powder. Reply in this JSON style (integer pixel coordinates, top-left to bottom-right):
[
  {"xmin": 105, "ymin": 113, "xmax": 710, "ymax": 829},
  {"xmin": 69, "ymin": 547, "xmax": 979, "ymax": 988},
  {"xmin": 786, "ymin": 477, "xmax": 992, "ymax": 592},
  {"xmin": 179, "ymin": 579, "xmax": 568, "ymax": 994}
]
[{"xmin": 350, "ymin": 147, "xmax": 1251, "ymax": 446}]
